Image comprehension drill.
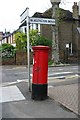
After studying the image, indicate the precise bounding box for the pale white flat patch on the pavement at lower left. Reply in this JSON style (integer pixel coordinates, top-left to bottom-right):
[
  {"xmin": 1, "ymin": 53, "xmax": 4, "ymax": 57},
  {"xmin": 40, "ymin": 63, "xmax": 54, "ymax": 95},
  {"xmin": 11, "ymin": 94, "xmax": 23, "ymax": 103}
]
[{"xmin": 0, "ymin": 86, "xmax": 25, "ymax": 103}]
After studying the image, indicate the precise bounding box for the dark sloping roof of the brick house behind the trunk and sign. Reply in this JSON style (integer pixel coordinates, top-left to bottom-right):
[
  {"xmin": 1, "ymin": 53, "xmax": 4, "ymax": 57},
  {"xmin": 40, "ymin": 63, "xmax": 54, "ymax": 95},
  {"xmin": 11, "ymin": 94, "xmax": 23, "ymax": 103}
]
[{"xmin": 19, "ymin": 8, "xmax": 80, "ymax": 27}]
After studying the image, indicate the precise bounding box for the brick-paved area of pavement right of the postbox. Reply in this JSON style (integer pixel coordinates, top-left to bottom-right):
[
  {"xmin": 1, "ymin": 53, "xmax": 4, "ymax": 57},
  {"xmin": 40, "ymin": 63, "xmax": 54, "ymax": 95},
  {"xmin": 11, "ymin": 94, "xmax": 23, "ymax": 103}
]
[{"xmin": 49, "ymin": 84, "xmax": 80, "ymax": 114}]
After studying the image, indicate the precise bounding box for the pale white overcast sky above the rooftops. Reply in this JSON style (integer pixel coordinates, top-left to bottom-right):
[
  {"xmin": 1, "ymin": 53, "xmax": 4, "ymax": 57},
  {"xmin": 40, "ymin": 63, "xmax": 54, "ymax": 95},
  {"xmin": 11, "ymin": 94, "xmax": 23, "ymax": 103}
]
[{"xmin": 0, "ymin": 0, "xmax": 80, "ymax": 32}]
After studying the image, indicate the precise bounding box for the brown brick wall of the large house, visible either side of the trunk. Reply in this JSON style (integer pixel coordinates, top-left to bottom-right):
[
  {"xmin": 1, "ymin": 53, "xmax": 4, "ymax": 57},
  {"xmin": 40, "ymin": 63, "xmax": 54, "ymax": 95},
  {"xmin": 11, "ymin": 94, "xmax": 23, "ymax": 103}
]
[{"xmin": 41, "ymin": 21, "xmax": 80, "ymax": 62}]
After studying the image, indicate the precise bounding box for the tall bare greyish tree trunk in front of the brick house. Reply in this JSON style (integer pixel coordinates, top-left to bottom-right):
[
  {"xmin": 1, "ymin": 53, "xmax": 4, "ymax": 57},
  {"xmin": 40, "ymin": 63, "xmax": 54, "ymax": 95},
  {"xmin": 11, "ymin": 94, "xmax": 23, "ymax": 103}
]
[{"xmin": 50, "ymin": 0, "xmax": 61, "ymax": 63}]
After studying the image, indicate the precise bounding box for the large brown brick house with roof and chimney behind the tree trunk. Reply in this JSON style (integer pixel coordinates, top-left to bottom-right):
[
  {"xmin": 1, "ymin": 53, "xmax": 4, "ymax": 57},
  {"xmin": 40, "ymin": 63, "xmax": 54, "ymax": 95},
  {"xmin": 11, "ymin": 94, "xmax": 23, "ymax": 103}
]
[{"xmin": 33, "ymin": 2, "xmax": 80, "ymax": 62}]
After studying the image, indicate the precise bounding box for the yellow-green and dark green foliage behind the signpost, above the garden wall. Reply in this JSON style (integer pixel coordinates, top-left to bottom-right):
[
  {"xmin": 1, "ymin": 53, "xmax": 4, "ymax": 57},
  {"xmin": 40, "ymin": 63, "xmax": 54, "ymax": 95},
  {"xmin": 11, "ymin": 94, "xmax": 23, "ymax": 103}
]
[{"xmin": 15, "ymin": 30, "xmax": 52, "ymax": 50}]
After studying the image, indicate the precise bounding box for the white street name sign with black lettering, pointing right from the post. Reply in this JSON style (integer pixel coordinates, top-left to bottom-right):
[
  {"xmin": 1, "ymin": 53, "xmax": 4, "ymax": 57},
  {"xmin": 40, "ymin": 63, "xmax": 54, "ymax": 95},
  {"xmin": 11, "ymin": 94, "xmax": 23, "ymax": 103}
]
[{"xmin": 29, "ymin": 17, "xmax": 55, "ymax": 25}]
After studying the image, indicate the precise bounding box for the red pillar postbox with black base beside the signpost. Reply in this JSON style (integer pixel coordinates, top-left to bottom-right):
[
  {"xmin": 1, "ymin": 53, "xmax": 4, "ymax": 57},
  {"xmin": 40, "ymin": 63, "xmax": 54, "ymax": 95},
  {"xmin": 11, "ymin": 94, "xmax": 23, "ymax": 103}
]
[{"xmin": 32, "ymin": 46, "xmax": 49, "ymax": 100}]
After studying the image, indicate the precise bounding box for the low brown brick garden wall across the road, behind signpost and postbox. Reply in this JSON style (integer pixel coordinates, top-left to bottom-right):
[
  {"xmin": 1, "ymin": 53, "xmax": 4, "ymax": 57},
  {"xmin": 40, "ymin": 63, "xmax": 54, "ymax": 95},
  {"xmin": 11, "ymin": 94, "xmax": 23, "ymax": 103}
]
[{"xmin": 0, "ymin": 50, "xmax": 52, "ymax": 65}]
